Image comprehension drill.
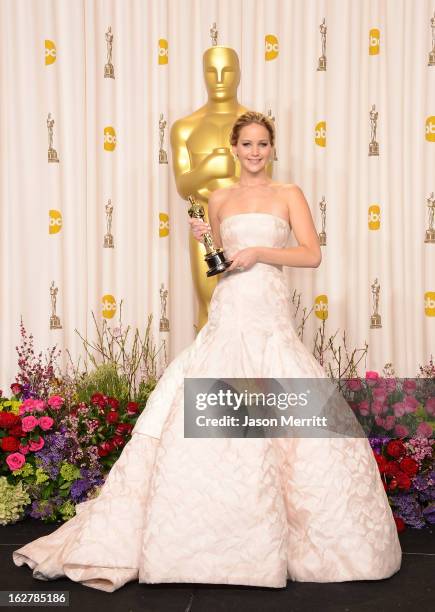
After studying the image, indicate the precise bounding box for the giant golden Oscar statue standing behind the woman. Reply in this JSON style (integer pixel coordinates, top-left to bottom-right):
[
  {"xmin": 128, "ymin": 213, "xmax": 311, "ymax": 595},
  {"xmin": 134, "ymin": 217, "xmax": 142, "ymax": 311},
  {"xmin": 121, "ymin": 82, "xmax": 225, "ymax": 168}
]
[{"xmin": 170, "ymin": 46, "xmax": 272, "ymax": 331}]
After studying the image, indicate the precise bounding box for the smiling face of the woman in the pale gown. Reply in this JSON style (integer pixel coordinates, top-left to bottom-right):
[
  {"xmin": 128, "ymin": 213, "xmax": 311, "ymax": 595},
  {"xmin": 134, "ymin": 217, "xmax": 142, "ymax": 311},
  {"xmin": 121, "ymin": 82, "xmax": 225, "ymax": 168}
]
[{"xmin": 233, "ymin": 123, "xmax": 272, "ymax": 174}]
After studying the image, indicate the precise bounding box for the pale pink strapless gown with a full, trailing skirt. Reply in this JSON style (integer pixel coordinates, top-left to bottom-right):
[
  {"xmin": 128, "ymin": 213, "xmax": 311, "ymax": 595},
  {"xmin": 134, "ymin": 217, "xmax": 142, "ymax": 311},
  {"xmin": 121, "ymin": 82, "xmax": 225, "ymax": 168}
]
[{"xmin": 13, "ymin": 213, "xmax": 401, "ymax": 591}]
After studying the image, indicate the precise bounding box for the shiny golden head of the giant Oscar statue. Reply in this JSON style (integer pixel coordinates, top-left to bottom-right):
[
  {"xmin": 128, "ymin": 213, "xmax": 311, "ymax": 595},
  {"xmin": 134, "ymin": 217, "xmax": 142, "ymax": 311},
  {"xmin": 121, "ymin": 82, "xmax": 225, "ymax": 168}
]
[{"xmin": 203, "ymin": 46, "xmax": 240, "ymax": 101}]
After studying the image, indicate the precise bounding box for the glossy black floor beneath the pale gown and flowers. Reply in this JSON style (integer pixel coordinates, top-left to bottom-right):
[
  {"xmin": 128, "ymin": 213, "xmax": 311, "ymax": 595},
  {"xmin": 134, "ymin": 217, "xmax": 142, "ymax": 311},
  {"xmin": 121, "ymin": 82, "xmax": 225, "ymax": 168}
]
[{"xmin": 0, "ymin": 519, "xmax": 435, "ymax": 612}]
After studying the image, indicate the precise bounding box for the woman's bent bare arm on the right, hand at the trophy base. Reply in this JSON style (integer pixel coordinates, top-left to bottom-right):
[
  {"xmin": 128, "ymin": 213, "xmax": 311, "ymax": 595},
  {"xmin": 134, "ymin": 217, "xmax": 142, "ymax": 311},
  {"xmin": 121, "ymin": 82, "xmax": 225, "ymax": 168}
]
[{"xmin": 255, "ymin": 185, "xmax": 322, "ymax": 268}]
